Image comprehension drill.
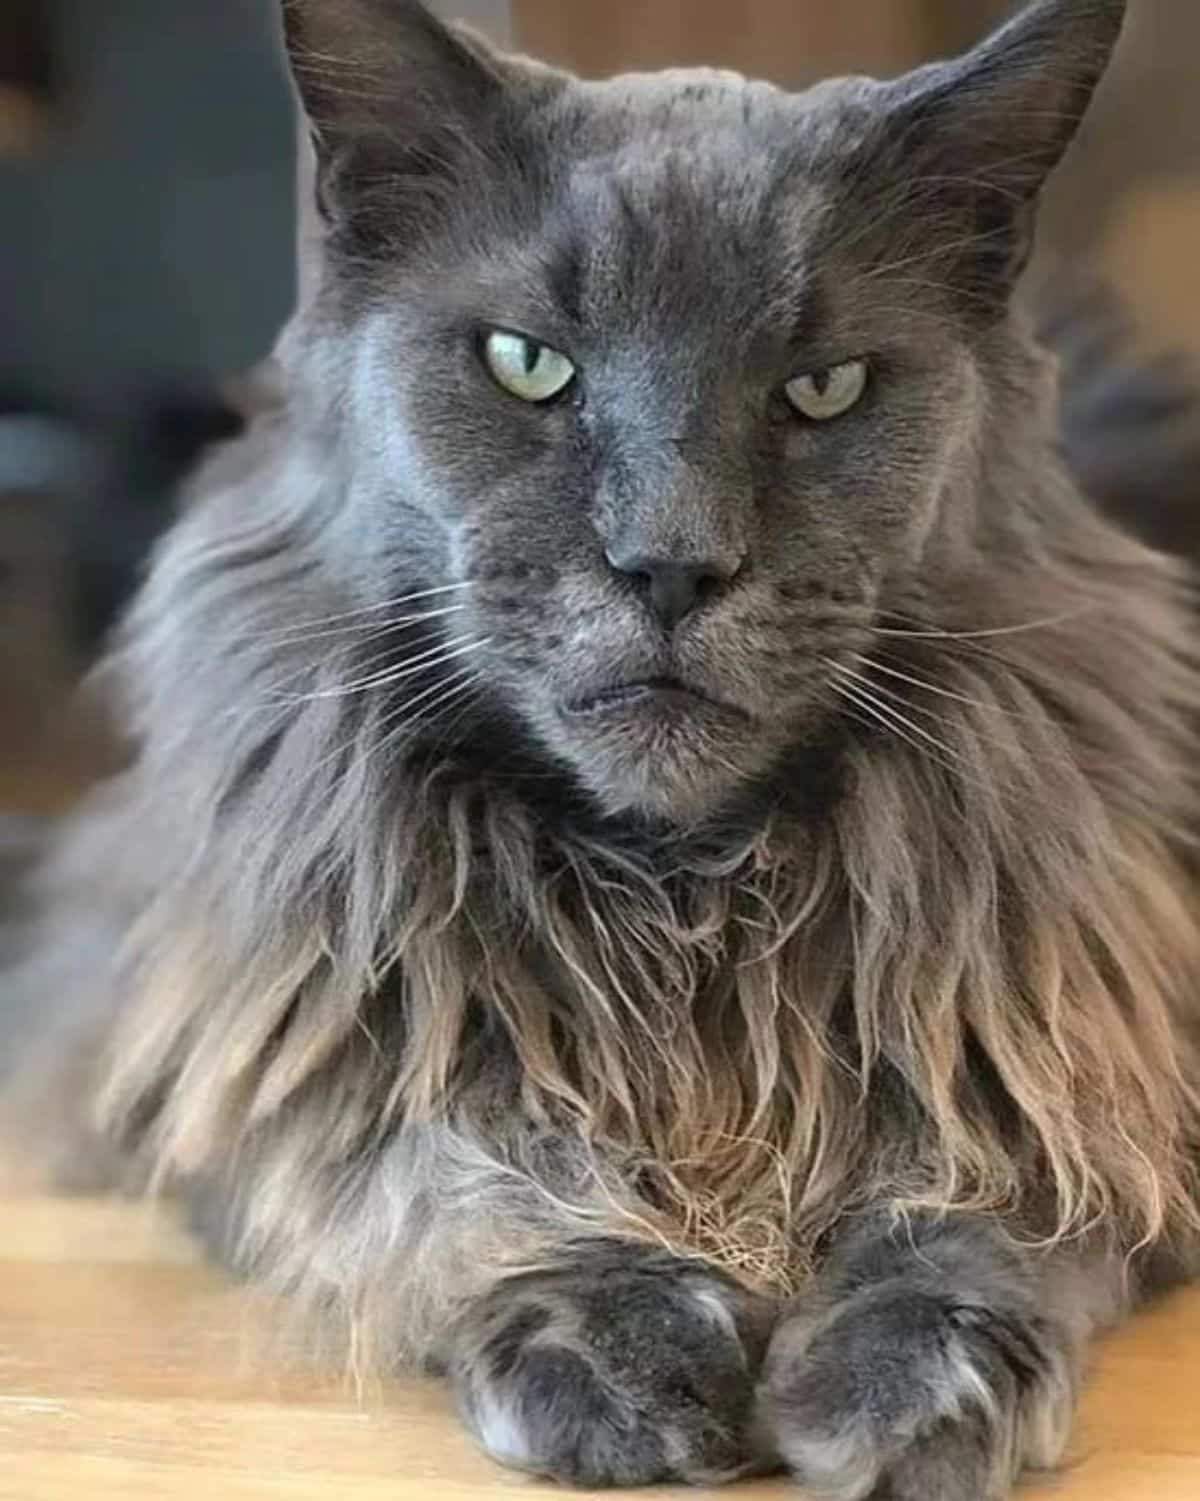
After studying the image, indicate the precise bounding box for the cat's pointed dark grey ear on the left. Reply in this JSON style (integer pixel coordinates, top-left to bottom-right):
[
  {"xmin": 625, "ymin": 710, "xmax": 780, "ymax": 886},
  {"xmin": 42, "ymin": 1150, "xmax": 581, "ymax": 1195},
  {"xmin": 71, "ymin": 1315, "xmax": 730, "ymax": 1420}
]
[{"xmin": 284, "ymin": 0, "xmax": 525, "ymax": 257}]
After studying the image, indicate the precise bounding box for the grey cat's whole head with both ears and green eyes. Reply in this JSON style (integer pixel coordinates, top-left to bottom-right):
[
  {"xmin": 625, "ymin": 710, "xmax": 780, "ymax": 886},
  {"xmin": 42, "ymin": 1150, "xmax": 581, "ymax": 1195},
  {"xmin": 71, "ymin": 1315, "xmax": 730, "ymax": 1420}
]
[{"xmin": 279, "ymin": 0, "xmax": 1125, "ymax": 821}]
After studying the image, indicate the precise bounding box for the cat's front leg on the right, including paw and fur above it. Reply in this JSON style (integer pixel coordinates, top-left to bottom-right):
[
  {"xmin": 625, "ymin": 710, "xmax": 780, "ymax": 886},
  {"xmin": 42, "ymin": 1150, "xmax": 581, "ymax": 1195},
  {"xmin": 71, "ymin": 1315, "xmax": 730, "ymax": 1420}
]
[{"xmin": 760, "ymin": 1217, "xmax": 1129, "ymax": 1501}]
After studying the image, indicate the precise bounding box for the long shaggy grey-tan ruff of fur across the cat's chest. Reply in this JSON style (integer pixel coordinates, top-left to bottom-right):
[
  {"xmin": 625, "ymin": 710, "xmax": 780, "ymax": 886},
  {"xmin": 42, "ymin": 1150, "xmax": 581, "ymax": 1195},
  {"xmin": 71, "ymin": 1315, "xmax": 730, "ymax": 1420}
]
[{"xmin": 96, "ymin": 585, "xmax": 1200, "ymax": 1285}]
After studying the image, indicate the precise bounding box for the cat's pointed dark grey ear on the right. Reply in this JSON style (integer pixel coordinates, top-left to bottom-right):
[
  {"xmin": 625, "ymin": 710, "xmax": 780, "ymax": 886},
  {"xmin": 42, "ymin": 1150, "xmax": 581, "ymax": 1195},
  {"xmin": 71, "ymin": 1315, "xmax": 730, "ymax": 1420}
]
[{"xmin": 882, "ymin": 0, "xmax": 1126, "ymax": 294}]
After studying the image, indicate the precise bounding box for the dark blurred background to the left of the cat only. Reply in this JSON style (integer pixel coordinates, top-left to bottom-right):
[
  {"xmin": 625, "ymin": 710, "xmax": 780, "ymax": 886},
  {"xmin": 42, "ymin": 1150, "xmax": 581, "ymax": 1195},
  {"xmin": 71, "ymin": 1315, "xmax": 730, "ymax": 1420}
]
[{"xmin": 0, "ymin": 0, "xmax": 296, "ymax": 812}]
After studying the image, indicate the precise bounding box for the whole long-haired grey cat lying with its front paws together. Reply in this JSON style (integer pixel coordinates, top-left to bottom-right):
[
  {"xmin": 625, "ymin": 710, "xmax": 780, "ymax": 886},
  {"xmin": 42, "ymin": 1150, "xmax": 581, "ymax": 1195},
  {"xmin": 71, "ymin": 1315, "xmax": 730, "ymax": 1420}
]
[{"xmin": 8, "ymin": 0, "xmax": 1200, "ymax": 1501}]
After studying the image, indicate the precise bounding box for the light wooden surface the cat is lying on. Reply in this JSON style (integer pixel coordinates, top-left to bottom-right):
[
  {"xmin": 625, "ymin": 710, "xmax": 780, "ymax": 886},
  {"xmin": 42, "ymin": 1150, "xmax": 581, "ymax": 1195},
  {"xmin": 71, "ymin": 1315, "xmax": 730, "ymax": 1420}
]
[{"xmin": 0, "ymin": 1198, "xmax": 1200, "ymax": 1501}]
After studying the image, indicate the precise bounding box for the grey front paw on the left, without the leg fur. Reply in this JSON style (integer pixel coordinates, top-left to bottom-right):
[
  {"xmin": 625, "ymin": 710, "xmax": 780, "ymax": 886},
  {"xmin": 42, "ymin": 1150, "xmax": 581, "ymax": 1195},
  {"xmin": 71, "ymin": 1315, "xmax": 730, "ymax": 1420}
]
[{"xmin": 451, "ymin": 1243, "xmax": 769, "ymax": 1486}]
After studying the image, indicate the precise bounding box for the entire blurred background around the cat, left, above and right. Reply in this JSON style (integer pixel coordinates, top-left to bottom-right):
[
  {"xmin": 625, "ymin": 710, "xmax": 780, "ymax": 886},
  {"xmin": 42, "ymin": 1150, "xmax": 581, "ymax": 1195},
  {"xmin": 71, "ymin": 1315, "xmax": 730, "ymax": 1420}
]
[{"xmin": 0, "ymin": 0, "xmax": 1200, "ymax": 829}]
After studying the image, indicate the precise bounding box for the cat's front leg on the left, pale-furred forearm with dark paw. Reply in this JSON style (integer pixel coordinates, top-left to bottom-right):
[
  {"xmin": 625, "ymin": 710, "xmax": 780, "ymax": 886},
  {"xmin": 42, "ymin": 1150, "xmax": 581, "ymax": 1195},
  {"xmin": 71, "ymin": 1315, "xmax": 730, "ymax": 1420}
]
[{"xmin": 181, "ymin": 1120, "xmax": 778, "ymax": 1486}]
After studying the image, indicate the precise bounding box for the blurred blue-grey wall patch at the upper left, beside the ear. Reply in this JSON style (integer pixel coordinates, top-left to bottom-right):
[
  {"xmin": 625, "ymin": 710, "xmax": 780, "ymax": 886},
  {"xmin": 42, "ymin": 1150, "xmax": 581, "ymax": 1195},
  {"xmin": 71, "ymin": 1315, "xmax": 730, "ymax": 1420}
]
[{"xmin": 0, "ymin": 0, "xmax": 294, "ymax": 404}]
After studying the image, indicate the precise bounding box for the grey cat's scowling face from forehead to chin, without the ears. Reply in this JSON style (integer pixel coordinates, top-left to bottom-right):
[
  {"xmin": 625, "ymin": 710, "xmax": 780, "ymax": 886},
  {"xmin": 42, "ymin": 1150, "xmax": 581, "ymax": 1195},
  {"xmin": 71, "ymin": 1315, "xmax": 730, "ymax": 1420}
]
[{"xmin": 372, "ymin": 80, "xmax": 979, "ymax": 815}]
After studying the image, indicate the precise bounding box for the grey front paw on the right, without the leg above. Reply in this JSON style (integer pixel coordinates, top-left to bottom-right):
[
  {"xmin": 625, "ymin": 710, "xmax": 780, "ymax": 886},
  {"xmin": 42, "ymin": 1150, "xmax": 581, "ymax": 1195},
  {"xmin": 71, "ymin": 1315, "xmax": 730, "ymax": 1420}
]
[{"xmin": 760, "ymin": 1279, "xmax": 1074, "ymax": 1501}]
